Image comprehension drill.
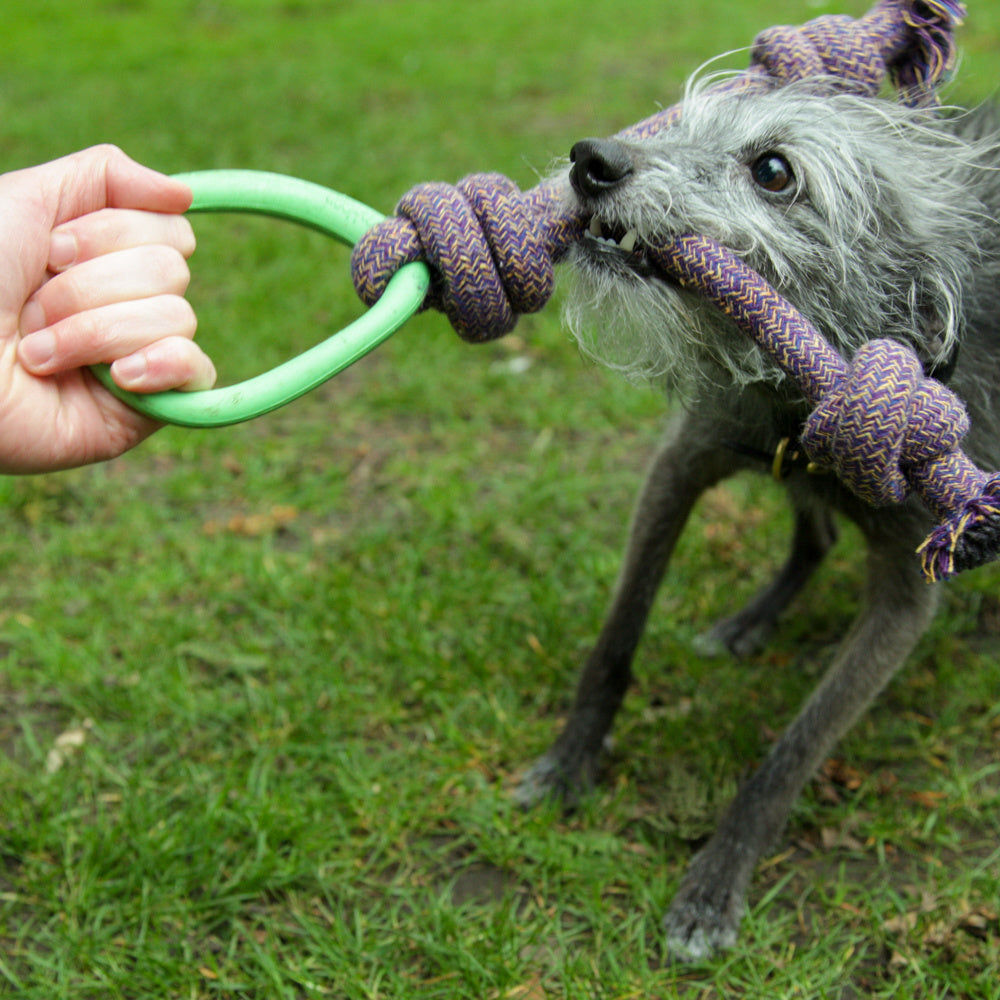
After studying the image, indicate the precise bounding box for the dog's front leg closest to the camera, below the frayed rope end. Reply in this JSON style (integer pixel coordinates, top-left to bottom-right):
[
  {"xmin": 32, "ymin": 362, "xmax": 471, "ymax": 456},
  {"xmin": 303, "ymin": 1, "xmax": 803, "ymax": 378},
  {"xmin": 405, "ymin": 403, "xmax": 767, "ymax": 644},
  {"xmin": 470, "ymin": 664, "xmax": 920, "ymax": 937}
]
[{"xmin": 664, "ymin": 513, "xmax": 937, "ymax": 961}]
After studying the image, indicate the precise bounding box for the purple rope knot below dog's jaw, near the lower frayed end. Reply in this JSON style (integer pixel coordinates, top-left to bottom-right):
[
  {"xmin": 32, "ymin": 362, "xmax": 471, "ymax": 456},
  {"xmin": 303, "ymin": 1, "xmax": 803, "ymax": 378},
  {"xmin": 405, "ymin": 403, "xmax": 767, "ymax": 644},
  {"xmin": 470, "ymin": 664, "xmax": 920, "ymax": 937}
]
[{"xmin": 802, "ymin": 340, "xmax": 969, "ymax": 506}]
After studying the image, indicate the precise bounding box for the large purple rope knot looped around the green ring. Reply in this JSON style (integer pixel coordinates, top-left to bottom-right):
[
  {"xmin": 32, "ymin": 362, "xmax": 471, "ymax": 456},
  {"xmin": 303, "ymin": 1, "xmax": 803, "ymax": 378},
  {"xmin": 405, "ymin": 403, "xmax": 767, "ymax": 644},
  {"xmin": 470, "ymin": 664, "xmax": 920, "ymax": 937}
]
[{"xmin": 351, "ymin": 174, "xmax": 555, "ymax": 342}]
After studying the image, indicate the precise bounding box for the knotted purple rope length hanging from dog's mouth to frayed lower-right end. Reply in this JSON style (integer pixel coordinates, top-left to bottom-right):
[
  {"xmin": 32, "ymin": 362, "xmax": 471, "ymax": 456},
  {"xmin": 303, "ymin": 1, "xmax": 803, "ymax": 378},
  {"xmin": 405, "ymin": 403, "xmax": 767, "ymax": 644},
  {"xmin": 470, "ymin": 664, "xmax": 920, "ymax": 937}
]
[{"xmin": 650, "ymin": 236, "xmax": 1000, "ymax": 580}]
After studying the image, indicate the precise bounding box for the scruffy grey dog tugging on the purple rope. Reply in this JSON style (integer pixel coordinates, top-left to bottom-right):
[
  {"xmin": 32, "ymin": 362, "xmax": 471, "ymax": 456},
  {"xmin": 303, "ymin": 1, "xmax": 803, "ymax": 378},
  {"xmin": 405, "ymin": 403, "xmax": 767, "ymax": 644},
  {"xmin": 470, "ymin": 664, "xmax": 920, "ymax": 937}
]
[{"xmin": 517, "ymin": 72, "xmax": 1000, "ymax": 959}]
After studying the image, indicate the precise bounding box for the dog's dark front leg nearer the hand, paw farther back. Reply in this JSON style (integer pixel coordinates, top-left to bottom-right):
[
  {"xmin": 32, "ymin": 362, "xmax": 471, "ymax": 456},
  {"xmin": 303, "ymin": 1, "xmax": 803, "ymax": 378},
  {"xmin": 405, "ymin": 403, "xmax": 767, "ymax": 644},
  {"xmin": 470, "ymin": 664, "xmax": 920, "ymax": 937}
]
[{"xmin": 514, "ymin": 416, "xmax": 739, "ymax": 806}]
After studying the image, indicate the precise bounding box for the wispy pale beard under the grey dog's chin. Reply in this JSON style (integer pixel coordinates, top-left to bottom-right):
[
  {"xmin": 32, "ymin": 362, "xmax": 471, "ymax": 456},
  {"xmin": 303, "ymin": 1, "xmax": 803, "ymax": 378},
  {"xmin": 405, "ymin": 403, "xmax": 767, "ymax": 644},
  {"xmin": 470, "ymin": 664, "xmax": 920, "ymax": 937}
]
[{"xmin": 563, "ymin": 245, "xmax": 785, "ymax": 398}]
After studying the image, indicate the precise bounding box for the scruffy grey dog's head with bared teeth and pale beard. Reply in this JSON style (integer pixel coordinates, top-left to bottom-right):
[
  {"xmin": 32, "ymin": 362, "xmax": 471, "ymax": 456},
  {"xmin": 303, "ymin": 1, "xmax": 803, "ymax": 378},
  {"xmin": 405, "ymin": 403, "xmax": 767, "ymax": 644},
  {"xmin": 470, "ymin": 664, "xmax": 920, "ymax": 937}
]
[{"xmin": 566, "ymin": 81, "xmax": 995, "ymax": 387}]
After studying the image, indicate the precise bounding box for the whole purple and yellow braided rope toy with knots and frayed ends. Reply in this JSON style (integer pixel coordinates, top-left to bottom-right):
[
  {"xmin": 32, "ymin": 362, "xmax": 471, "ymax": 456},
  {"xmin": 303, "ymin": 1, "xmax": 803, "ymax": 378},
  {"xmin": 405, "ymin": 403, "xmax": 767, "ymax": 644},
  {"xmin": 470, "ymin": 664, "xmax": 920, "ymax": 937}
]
[{"xmin": 351, "ymin": 0, "xmax": 1000, "ymax": 581}]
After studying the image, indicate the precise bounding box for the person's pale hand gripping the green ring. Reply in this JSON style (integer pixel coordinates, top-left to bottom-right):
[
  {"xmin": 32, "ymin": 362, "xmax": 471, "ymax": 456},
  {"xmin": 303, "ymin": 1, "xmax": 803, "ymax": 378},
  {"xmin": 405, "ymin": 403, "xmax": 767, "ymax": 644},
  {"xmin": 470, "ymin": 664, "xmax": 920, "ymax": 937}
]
[{"xmin": 0, "ymin": 146, "xmax": 215, "ymax": 473}]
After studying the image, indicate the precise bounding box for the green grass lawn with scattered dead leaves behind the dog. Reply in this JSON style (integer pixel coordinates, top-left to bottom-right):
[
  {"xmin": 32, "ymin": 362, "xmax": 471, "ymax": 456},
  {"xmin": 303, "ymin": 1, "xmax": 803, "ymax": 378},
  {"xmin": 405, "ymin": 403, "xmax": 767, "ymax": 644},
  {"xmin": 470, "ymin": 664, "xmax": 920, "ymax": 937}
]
[{"xmin": 0, "ymin": 0, "xmax": 1000, "ymax": 1000}]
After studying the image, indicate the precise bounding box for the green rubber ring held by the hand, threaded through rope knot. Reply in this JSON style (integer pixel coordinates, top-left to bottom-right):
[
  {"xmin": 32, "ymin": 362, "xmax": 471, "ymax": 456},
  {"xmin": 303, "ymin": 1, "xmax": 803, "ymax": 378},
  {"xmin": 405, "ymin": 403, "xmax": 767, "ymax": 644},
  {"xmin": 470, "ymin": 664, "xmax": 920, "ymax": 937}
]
[{"xmin": 92, "ymin": 170, "xmax": 430, "ymax": 427}]
